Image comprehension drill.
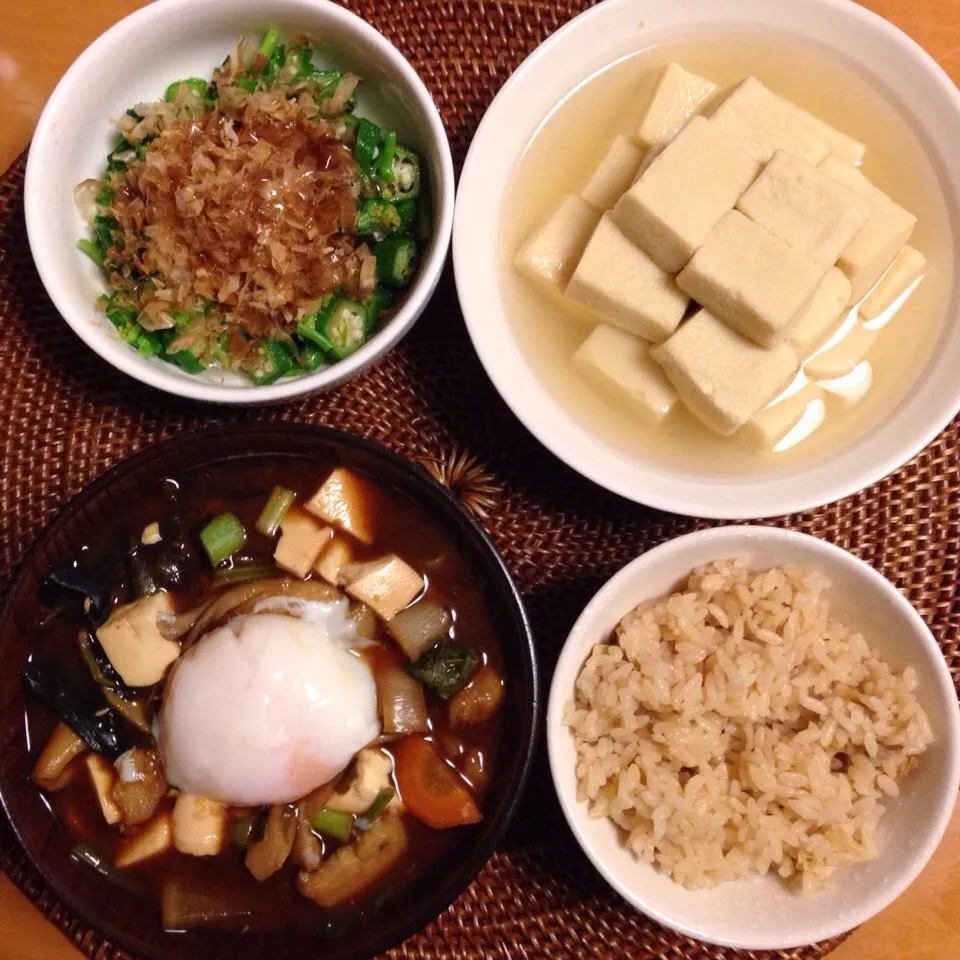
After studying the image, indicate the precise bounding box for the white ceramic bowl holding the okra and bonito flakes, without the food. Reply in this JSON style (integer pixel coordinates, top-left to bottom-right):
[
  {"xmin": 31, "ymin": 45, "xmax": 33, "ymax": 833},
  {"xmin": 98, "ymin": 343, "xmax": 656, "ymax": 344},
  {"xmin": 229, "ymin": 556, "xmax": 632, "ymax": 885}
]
[{"xmin": 24, "ymin": 0, "xmax": 454, "ymax": 404}]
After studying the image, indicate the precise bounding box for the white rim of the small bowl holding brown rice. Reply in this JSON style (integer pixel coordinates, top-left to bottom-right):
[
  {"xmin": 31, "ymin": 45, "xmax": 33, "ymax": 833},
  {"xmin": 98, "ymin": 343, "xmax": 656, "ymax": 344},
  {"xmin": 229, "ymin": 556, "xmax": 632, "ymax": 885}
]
[{"xmin": 546, "ymin": 524, "xmax": 960, "ymax": 950}]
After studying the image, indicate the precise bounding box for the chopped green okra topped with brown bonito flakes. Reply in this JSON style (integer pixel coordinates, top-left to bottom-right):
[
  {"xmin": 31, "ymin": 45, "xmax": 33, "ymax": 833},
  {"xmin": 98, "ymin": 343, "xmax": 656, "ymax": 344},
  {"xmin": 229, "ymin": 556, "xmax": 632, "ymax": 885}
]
[{"xmin": 77, "ymin": 30, "xmax": 430, "ymax": 385}]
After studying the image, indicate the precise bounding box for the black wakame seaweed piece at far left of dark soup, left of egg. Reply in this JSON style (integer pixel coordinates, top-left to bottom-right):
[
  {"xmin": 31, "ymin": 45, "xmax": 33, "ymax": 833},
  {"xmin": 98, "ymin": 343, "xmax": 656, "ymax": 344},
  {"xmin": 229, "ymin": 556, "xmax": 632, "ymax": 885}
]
[{"xmin": 20, "ymin": 655, "xmax": 126, "ymax": 760}]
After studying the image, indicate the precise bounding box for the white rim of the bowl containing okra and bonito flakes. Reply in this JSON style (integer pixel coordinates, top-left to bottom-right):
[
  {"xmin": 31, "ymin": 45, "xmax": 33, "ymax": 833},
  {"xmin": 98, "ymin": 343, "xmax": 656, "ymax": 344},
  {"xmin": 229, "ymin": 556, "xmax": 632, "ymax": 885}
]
[{"xmin": 24, "ymin": 0, "xmax": 455, "ymax": 405}]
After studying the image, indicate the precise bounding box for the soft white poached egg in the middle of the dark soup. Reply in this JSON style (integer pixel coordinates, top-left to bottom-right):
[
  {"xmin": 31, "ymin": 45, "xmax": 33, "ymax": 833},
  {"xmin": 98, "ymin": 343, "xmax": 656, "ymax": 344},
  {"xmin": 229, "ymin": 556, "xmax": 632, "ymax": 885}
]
[{"xmin": 156, "ymin": 597, "xmax": 380, "ymax": 806}]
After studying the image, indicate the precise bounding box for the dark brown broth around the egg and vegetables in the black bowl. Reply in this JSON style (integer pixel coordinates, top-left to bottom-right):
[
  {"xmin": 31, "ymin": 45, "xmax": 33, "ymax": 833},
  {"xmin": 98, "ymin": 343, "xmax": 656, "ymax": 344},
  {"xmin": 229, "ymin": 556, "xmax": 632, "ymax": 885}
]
[{"xmin": 27, "ymin": 456, "xmax": 504, "ymax": 935}]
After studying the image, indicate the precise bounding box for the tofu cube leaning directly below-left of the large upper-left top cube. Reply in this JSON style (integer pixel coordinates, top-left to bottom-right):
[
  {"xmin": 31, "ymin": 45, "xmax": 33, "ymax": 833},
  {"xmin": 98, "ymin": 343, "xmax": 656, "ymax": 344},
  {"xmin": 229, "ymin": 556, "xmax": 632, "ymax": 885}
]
[{"xmin": 566, "ymin": 214, "xmax": 690, "ymax": 343}]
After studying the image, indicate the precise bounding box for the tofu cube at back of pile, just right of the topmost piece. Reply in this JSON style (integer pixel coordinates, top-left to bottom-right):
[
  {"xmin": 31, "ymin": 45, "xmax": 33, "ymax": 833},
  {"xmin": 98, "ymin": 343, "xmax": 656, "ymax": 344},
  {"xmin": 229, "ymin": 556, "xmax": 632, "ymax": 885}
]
[{"xmin": 710, "ymin": 77, "xmax": 829, "ymax": 165}]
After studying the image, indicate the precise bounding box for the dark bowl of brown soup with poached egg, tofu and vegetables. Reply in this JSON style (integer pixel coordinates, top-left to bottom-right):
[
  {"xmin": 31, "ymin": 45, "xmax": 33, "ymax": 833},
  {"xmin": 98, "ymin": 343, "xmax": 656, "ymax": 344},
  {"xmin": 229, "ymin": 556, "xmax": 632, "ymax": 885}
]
[{"xmin": 0, "ymin": 424, "xmax": 538, "ymax": 960}]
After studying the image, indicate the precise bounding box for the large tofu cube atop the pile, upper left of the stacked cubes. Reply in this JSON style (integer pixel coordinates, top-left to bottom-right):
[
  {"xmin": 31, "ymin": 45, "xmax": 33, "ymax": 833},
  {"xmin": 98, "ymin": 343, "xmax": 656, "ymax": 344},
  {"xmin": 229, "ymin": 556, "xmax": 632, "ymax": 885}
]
[{"xmin": 613, "ymin": 117, "xmax": 760, "ymax": 273}]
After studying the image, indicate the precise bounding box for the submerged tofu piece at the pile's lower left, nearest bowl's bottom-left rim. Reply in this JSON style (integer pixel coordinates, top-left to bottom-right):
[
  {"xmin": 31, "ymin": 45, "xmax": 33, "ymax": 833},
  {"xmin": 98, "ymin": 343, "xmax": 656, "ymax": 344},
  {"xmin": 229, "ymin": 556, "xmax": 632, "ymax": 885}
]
[{"xmin": 573, "ymin": 323, "xmax": 677, "ymax": 422}]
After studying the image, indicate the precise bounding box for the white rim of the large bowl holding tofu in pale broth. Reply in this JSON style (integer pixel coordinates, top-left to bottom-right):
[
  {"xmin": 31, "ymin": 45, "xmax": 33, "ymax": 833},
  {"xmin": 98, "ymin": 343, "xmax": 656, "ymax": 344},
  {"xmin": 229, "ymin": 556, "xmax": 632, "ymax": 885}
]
[{"xmin": 453, "ymin": 0, "xmax": 960, "ymax": 520}]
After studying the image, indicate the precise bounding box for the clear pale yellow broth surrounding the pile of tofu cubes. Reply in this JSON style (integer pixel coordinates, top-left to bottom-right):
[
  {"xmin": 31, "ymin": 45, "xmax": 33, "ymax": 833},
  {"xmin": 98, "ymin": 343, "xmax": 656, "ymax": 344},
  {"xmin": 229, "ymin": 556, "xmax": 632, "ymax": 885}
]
[{"xmin": 500, "ymin": 32, "xmax": 955, "ymax": 476}]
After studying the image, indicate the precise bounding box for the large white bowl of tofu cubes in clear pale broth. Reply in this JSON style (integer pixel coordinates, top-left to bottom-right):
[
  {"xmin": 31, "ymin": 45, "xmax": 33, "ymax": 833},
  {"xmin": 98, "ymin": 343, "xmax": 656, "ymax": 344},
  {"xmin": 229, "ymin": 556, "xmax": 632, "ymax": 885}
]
[{"xmin": 454, "ymin": 0, "xmax": 960, "ymax": 518}]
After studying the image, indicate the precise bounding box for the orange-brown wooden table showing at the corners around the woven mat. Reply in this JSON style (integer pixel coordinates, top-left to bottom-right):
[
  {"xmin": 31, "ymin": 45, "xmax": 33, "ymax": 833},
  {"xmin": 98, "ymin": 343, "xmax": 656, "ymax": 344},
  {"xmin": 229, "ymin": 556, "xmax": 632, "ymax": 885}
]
[{"xmin": 0, "ymin": 0, "xmax": 960, "ymax": 960}]
